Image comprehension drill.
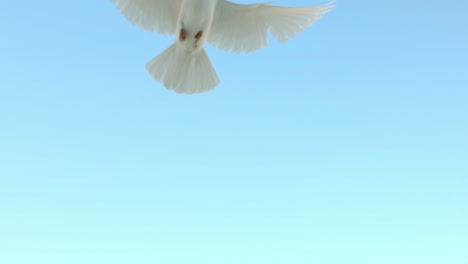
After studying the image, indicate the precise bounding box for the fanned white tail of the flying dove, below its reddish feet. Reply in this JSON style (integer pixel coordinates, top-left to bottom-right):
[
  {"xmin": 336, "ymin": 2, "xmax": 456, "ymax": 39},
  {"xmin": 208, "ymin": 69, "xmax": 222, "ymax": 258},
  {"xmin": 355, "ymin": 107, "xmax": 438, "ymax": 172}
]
[{"xmin": 146, "ymin": 43, "xmax": 219, "ymax": 94}]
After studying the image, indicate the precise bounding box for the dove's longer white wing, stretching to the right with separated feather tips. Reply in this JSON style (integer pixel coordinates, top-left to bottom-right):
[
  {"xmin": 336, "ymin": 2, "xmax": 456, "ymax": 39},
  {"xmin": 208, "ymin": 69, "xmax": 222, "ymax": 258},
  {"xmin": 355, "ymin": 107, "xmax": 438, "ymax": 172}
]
[{"xmin": 208, "ymin": 0, "xmax": 335, "ymax": 53}]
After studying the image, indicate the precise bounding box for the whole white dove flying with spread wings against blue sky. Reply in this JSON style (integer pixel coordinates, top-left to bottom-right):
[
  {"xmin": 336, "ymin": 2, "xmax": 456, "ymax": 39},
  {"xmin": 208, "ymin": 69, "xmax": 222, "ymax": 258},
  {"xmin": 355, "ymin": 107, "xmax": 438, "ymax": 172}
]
[{"xmin": 110, "ymin": 0, "xmax": 334, "ymax": 94}]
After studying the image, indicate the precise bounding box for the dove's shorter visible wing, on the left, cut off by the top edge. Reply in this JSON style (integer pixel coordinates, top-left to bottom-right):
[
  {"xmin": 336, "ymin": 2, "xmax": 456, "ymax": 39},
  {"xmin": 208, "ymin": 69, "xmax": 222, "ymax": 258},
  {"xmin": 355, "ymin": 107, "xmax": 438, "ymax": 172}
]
[{"xmin": 110, "ymin": 0, "xmax": 182, "ymax": 35}]
